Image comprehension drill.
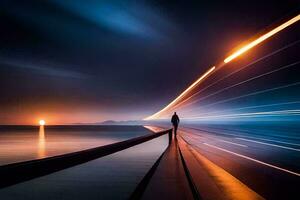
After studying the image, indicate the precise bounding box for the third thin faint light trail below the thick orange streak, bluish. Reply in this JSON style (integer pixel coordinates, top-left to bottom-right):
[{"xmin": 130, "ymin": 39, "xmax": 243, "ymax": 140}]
[{"xmin": 180, "ymin": 81, "xmax": 300, "ymax": 115}]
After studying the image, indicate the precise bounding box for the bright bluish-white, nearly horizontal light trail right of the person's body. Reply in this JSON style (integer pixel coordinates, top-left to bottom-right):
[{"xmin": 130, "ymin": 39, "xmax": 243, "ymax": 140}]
[{"xmin": 182, "ymin": 110, "xmax": 300, "ymax": 120}]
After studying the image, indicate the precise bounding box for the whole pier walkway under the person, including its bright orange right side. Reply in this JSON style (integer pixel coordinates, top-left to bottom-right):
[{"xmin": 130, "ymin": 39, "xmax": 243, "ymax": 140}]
[{"xmin": 135, "ymin": 128, "xmax": 264, "ymax": 200}]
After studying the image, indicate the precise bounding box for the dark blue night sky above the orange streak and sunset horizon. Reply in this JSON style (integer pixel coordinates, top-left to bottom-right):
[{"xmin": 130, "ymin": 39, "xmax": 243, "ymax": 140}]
[{"xmin": 0, "ymin": 0, "xmax": 299, "ymax": 124}]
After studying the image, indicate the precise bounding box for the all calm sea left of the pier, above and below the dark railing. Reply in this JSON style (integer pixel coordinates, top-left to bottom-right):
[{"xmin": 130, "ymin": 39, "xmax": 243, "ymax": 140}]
[{"xmin": 0, "ymin": 126, "xmax": 168, "ymax": 200}]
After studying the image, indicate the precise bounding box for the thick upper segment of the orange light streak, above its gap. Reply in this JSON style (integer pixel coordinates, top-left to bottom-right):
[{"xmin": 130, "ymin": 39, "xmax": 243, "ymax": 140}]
[{"xmin": 224, "ymin": 14, "xmax": 300, "ymax": 63}]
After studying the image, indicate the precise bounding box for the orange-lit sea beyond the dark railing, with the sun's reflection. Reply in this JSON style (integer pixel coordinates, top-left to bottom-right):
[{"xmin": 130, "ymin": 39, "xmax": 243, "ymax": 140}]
[{"xmin": 0, "ymin": 126, "xmax": 155, "ymax": 165}]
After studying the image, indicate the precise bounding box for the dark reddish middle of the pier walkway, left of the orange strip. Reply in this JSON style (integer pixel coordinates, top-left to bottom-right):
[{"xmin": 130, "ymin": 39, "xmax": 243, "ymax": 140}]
[{"xmin": 131, "ymin": 138, "xmax": 201, "ymax": 200}]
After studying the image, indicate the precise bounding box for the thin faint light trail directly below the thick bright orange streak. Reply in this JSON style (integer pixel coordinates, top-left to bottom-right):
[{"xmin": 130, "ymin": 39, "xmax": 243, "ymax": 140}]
[{"xmin": 169, "ymin": 40, "xmax": 300, "ymax": 109}]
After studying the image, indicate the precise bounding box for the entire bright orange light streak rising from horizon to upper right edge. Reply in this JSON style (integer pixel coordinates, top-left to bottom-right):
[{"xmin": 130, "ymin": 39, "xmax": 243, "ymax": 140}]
[{"xmin": 143, "ymin": 15, "xmax": 300, "ymax": 120}]
